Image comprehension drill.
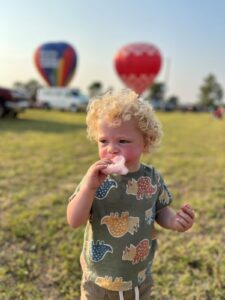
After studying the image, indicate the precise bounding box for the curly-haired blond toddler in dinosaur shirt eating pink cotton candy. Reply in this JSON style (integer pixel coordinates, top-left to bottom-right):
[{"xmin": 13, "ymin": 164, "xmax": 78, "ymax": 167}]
[{"xmin": 67, "ymin": 89, "xmax": 194, "ymax": 300}]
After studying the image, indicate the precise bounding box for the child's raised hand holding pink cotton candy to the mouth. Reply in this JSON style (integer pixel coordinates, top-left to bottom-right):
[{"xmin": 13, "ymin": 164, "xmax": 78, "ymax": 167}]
[{"xmin": 82, "ymin": 159, "xmax": 111, "ymax": 190}]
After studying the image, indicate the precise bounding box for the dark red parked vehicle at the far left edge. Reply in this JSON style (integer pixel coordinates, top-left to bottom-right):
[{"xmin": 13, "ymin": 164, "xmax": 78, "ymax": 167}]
[{"xmin": 0, "ymin": 88, "xmax": 29, "ymax": 118}]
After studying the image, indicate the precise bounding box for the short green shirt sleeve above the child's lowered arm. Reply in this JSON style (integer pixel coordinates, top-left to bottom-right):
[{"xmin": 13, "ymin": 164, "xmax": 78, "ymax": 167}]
[{"xmin": 156, "ymin": 174, "xmax": 173, "ymax": 212}]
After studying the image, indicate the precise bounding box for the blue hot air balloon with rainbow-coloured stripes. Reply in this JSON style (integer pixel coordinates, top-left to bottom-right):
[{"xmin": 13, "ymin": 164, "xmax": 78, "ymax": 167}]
[{"xmin": 34, "ymin": 42, "xmax": 77, "ymax": 86}]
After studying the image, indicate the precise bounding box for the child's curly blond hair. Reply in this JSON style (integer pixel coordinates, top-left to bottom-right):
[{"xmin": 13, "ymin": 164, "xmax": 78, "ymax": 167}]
[{"xmin": 86, "ymin": 89, "xmax": 162, "ymax": 152}]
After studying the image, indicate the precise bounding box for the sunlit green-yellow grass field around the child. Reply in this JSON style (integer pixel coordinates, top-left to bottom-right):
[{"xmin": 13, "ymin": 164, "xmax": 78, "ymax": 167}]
[{"xmin": 0, "ymin": 110, "xmax": 225, "ymax": 300}]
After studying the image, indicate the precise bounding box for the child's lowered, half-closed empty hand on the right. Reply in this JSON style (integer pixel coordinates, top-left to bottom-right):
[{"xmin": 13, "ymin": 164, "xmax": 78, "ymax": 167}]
[{"xmin": 173, "ymin": 204, "xmax": 195, "ymax": 232}]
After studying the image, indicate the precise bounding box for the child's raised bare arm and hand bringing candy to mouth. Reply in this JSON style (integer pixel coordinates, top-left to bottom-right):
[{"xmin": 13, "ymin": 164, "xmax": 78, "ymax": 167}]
[{"xmin": 67, "ymin": 160, "xmax": 109, "ymax": 228}]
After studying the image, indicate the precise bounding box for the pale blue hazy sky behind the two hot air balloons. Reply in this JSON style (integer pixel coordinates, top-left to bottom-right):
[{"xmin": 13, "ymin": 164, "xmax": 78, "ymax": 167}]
[{"xmin": 0, "ymin": 0, "xmax": 225, "ymax": 102}]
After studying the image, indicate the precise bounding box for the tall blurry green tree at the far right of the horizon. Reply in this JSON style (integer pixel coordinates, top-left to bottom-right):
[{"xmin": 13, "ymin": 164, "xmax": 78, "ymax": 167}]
[{"xmin": 199, "ymin": 74, "xmax": 223, "ymax": 107}]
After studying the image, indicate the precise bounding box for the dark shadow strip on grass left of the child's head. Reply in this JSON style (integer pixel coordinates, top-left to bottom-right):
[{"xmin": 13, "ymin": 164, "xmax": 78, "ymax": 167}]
[{"xmin": 0, "ymin": 118, "xmax": 86, "ymax": 133}]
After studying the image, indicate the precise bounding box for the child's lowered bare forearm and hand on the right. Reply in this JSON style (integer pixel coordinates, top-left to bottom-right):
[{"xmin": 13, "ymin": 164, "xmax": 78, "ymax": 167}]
[{"xmin": 156, "ymin": 204, "xmax": 195, "ymax": 232}]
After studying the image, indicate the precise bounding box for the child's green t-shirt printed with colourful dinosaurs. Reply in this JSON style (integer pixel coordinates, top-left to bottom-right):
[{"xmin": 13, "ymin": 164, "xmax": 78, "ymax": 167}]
[{"xmin": 71, "ymin": 164, "xmax": 172, "ymax": 291}]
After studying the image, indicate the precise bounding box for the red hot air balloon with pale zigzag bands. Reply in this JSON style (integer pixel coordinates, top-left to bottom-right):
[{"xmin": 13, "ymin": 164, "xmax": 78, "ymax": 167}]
[{"xmin": 114, "ymin": 43, "xmax": 161, "ymax": 94}]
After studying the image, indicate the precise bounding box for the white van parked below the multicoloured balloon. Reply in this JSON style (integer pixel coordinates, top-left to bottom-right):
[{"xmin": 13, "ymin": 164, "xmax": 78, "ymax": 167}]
[{"xmin": 37, "ymin": 87, "xmax": 89, "ymax": 112}]
